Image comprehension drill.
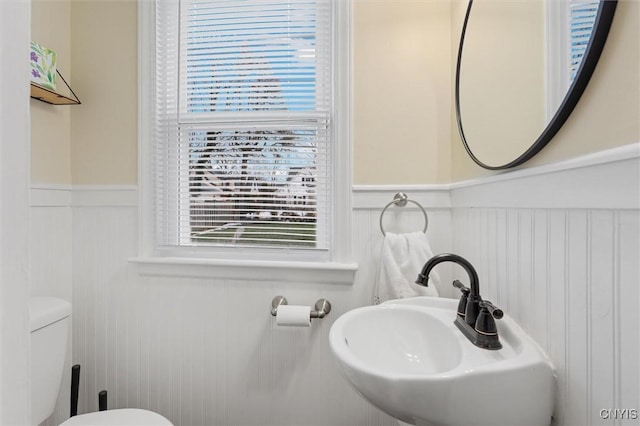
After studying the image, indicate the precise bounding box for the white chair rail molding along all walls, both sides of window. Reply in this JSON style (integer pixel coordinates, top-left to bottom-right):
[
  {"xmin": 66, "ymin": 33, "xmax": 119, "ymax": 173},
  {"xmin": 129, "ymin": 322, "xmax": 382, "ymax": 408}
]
[{"xmin": 30, "ymin": 142, "xmax": 640, "ymax": 210}]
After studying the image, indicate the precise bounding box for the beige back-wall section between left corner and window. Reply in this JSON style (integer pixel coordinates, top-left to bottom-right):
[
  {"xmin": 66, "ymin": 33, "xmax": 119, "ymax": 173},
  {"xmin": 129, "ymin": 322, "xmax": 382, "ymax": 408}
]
[{"xmin": 71, "ymin": 0, "xmax": 138, "ymax": 185}]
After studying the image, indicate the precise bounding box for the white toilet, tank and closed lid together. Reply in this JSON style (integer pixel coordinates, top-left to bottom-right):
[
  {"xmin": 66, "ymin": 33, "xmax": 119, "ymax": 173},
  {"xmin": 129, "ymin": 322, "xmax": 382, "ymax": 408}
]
[{"xmin": 29, "ymin": 297, "xmax": 172, "ymax": 426}]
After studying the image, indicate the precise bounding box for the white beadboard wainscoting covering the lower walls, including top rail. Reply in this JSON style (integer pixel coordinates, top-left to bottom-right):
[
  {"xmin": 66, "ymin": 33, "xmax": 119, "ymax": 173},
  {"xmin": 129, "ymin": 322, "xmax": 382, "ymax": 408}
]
[{"xmin": 32, "ymin": 145, "xmax": 640, "ymax": 425}]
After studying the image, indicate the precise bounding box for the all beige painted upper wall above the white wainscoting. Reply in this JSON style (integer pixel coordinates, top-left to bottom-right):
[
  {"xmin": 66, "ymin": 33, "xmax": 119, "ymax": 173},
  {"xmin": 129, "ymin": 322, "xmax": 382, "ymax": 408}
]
[{"xmin": 31, "ymin": 0, "xmax": 640, "ymax": 185}]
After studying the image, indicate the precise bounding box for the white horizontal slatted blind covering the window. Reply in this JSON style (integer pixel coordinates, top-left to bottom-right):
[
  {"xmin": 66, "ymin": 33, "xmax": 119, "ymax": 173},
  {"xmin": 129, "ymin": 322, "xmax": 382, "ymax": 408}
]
[{"xmin": 154, "ymin": 0, "xmax": 333, "ymax": 249}]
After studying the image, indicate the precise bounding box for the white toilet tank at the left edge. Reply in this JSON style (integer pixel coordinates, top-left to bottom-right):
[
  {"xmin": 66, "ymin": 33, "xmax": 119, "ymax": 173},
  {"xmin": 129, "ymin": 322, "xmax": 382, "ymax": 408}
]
[{"xmin": 29, "ymin": 297, "xmax": 71, "ymax": 425}]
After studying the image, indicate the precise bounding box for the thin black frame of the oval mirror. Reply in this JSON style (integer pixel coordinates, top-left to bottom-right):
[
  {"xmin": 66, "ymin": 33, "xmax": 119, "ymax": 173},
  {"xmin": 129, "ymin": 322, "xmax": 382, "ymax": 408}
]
[{"xmin": 455, "ymin": 0, "xmax": 618, "ymax": 170}]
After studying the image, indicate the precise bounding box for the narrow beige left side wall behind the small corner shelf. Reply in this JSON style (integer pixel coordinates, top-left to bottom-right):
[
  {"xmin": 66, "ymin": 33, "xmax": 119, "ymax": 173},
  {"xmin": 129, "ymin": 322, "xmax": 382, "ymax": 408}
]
[{"xmin": 31, "ymin": 0, "xmax": 72, "ymax": 185}]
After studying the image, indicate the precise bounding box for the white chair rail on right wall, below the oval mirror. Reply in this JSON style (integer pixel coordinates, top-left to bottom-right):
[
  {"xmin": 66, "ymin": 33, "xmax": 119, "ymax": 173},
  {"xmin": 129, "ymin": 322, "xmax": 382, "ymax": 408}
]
[{"xmin": 450, "ymin": 143, "xmax": 640, "ymax": 209}]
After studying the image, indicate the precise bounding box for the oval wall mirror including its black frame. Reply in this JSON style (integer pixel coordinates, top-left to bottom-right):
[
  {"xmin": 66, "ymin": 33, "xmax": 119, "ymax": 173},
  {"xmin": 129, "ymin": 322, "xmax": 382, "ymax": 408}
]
[{"xmin": 455, "ymin": 0, "xmax": 617, "ymax": 170}]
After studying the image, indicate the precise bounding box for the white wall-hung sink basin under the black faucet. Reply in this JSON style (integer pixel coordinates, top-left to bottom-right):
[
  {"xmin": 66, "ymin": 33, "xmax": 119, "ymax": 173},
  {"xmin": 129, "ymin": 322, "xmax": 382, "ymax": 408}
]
[{"xmin": 329, "ymin": 297, "xmax": 555, "ymax": 426}]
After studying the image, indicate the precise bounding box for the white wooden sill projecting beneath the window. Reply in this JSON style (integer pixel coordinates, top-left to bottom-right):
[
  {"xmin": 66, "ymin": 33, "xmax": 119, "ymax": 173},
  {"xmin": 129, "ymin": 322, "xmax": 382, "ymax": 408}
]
[{"xmin": 129, "ymin": 257, "xmax": 358, "ymax": 285}]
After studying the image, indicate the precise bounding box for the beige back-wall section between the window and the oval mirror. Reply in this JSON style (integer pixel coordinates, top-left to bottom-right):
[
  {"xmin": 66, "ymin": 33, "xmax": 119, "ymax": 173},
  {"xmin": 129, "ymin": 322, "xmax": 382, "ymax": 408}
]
[{"xmin": 353, "ymin": 0, "xmax": 452, "ymax": 184}]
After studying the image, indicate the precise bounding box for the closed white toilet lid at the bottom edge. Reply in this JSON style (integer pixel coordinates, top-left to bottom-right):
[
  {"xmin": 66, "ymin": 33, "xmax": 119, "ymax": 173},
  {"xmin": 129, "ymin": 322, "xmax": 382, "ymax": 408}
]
[{"xmin": 60, "ymin": 408, "xmax": 173, "ymax": 426}]
